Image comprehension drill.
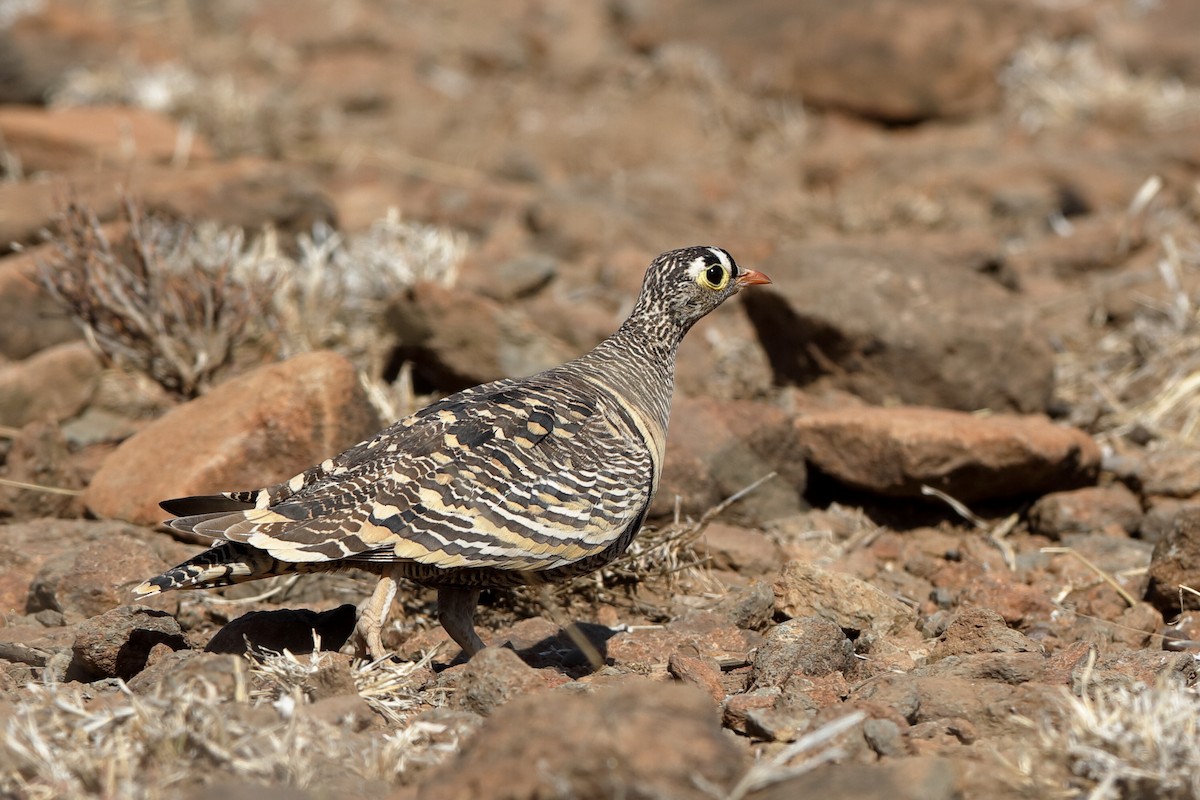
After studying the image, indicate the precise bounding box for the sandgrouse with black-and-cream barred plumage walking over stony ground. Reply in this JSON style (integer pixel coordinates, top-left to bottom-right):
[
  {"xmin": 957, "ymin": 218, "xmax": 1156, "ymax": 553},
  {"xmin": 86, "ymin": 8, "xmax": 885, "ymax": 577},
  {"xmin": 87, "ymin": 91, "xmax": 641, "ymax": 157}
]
[{"xmin": 134, "ymin": 247, "xmax": 770, "ymax": 658}]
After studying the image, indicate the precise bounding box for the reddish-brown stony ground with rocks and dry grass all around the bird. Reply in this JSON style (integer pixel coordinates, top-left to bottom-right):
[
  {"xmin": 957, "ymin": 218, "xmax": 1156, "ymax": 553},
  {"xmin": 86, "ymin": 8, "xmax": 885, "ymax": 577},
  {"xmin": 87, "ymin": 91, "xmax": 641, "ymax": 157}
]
[{"xmin": 0, "ymin": 0, "xmax": 1200, "ymax": 800}]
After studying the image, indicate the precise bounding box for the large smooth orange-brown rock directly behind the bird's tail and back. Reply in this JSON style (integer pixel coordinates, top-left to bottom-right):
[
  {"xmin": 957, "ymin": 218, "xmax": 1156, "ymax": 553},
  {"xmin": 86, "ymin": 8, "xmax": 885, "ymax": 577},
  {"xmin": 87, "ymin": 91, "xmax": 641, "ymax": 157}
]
[{"xmin": 84, "ymin": 351, "xmax": 380, "ymax": 524}]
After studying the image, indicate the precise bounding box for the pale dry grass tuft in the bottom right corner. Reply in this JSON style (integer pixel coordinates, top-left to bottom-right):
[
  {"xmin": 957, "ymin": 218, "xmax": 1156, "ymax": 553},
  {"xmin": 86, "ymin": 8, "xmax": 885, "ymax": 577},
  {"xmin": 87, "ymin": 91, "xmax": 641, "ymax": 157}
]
[{"xmin": 1038, "ymin": 682, "xmax": 1200, "ymax": 800}]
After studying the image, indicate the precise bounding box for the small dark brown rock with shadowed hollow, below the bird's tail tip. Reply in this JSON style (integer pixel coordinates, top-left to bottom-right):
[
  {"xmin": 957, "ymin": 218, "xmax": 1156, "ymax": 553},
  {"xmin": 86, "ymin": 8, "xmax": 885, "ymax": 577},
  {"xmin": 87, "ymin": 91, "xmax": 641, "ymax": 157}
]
[{"xmin": 72, "ymin": 606, "xmax": 188, "ymax": 680}]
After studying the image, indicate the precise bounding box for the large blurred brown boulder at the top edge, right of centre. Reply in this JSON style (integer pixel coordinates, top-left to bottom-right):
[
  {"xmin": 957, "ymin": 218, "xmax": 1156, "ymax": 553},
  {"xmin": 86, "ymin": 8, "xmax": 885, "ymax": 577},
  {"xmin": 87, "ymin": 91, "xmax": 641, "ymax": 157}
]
[{"xmin": 625, "ymin": 0, "xmax": 1050, "ymax": 122}]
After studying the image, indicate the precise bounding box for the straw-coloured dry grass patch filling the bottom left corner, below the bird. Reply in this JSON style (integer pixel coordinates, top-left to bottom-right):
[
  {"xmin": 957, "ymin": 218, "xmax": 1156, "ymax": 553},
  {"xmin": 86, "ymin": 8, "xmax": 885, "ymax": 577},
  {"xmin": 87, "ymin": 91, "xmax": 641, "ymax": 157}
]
[{"xmin": 0, "ymin": 654, "xmax": 457, "ymax": 800}]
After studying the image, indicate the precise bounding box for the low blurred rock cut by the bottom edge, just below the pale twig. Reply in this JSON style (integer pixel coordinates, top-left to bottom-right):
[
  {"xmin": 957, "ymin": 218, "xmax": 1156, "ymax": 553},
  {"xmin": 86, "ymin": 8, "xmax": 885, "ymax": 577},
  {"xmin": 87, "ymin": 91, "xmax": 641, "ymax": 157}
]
[{"xmin": 746, "ymin": 756, "xmax": 965, "ymax": 800}]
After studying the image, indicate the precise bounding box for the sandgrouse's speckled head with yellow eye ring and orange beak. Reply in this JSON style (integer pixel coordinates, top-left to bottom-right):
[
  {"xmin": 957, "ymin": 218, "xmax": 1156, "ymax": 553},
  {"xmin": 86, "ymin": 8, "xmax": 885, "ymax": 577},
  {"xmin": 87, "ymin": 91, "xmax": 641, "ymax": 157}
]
[{"xmin": 634, "ymin": 247, "xmax": 770, "ymax": 332}]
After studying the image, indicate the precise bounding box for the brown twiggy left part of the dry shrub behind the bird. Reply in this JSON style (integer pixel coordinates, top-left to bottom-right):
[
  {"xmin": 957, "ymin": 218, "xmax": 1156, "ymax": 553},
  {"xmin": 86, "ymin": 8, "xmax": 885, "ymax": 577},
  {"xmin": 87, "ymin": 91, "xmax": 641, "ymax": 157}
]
[{"xmin": 40, "ymin": 198, "xmax": 271, "ymax": 397}]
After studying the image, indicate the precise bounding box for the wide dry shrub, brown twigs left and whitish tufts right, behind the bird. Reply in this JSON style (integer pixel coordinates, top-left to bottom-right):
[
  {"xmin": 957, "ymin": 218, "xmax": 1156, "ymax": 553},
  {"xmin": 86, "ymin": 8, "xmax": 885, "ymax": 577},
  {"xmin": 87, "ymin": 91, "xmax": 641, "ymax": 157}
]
[{"xmin": 40, "ymin": 199, "xmax": 466, "ymax": 416}]
